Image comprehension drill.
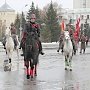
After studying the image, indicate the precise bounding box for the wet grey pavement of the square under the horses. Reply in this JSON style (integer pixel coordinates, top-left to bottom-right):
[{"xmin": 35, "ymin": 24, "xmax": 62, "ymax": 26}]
[{"xmin": 0, "ymin": 43, "xmax": 90, "ymax": 90}]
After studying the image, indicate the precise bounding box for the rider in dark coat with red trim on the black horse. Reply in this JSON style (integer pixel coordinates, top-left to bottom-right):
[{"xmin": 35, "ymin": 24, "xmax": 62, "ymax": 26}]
[{"xmin": 21, "ymin": 14, "xmax": 44, "ymax": 55}]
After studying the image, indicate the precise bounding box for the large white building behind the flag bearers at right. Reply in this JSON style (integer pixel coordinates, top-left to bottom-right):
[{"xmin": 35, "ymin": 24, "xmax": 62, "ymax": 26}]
[{"xmin": 59, "ymin": 0, "xmax": 90, "ymax": 37}]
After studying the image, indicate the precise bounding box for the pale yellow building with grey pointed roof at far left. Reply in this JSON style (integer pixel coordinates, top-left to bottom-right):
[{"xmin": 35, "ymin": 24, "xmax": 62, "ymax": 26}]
[{"xmin": 0, "ymin": 2, "xmax": 16, "ymax": 39}]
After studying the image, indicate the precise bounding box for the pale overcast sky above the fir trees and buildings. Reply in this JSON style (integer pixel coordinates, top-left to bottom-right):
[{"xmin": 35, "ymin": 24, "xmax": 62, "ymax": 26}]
[{"xmin": 0, "ymin": 0, "xmax": 73, "ymax": 12}]
